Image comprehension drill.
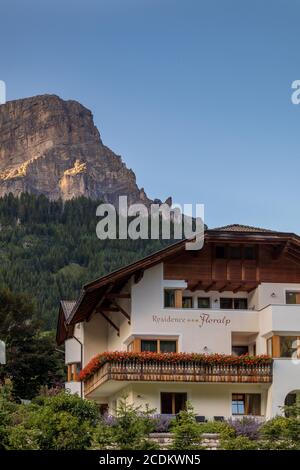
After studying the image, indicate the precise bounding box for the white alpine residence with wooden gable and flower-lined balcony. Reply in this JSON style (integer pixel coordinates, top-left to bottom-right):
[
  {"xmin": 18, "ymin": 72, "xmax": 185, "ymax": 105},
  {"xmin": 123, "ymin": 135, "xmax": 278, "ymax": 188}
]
[{"xmin": 57, "ymin": 225, "xmax": 300, "ymax": 419}]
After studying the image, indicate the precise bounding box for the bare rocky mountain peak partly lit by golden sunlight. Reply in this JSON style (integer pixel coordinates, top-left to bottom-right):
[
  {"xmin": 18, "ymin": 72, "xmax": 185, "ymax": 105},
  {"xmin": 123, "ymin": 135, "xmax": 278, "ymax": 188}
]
[{"xmin": 0, "ymin": 95, "xmax": 162, "ymax": 205}]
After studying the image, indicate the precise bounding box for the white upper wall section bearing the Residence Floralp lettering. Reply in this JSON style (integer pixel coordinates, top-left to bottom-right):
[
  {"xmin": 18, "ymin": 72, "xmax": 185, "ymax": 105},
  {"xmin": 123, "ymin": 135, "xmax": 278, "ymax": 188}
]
[{"xmin": 132, "ymin": 265, "xmax": 265, "ymax": 354}]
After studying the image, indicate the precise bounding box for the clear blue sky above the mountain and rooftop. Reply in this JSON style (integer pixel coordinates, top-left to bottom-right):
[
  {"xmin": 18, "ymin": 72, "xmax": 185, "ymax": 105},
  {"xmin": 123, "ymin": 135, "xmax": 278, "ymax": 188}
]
[{"xmin": 0, "ymin": 0, "xmax": 300, "ymax": 233}]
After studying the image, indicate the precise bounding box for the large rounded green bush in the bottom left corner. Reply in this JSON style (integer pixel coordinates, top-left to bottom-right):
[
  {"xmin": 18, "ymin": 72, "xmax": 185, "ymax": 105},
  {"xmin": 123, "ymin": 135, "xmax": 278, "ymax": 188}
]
[{"xmin": 5, "ymin": 393, "xmax": 97, "ymax": 450}]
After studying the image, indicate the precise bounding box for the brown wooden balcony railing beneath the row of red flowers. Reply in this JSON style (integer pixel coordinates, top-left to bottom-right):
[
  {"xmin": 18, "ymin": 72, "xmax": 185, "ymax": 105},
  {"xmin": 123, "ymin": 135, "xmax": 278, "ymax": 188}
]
[{"xmin": 84, "ymin": 358, "xmax": 273, "ymax": 395}]
